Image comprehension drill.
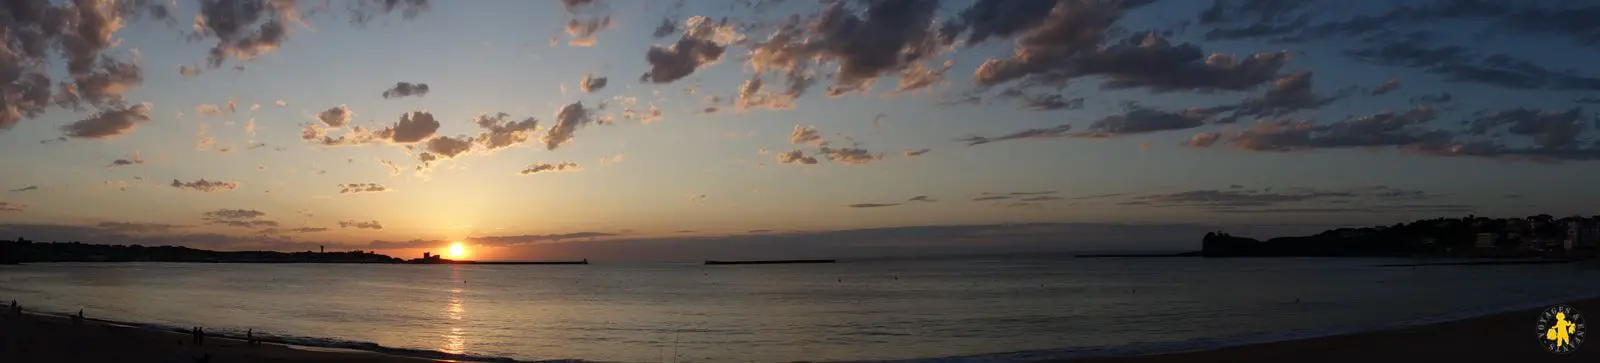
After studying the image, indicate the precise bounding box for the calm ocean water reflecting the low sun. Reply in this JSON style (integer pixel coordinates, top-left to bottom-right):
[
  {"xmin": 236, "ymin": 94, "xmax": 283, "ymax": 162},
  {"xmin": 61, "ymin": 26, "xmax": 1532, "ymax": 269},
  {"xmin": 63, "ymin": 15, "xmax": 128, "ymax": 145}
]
[{"xmin": 0, "ymin": 256, "xmax": 1600, "ymax": 361}]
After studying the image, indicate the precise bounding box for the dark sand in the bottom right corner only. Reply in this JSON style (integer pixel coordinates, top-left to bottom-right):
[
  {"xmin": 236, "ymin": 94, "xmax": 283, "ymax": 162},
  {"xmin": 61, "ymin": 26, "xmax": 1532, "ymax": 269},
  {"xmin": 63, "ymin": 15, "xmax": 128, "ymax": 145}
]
[{"xmin": 1061, "ymin": 299, "xmax": 1600, "ymax": 363}]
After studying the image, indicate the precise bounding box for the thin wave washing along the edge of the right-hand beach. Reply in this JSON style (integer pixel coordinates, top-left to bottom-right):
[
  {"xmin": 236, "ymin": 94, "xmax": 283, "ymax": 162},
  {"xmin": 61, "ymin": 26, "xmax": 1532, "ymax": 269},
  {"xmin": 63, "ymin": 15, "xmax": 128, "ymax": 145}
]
[{"xmin": 846, "ymin": 293, "xmax": 1600, "ymax": 363}]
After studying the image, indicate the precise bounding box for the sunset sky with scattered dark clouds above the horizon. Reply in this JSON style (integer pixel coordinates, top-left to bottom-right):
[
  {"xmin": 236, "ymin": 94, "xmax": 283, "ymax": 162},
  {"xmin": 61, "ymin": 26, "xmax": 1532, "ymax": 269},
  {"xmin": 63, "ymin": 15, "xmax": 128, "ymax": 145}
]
[{"xmin": 0, "ymin": 0, "xmax": 1600, "ymax": 259}]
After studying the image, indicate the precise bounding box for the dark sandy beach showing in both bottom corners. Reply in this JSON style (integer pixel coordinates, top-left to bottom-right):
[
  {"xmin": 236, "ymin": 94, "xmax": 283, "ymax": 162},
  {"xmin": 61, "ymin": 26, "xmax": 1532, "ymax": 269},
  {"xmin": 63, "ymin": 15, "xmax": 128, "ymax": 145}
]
[{"xmin": 0, "ymin": 299, "xmax": 1600, "ymax": 363}]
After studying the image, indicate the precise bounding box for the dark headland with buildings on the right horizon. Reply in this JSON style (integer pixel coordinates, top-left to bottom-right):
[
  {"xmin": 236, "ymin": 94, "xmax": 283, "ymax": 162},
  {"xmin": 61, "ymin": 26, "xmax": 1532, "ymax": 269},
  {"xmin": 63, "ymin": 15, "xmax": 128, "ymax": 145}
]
[{"xmin": 1198, "ymin": 214, "xmax": 1600, "ymax": 259}]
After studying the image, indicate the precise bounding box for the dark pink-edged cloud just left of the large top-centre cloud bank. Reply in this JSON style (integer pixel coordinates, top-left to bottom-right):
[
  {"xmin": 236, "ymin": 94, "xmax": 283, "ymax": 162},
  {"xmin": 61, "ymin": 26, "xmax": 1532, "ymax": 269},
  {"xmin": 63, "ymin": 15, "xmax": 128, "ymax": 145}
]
[{"xmin": 640, "ymin": 16, "xmax": 744, "ymax": 83}]
